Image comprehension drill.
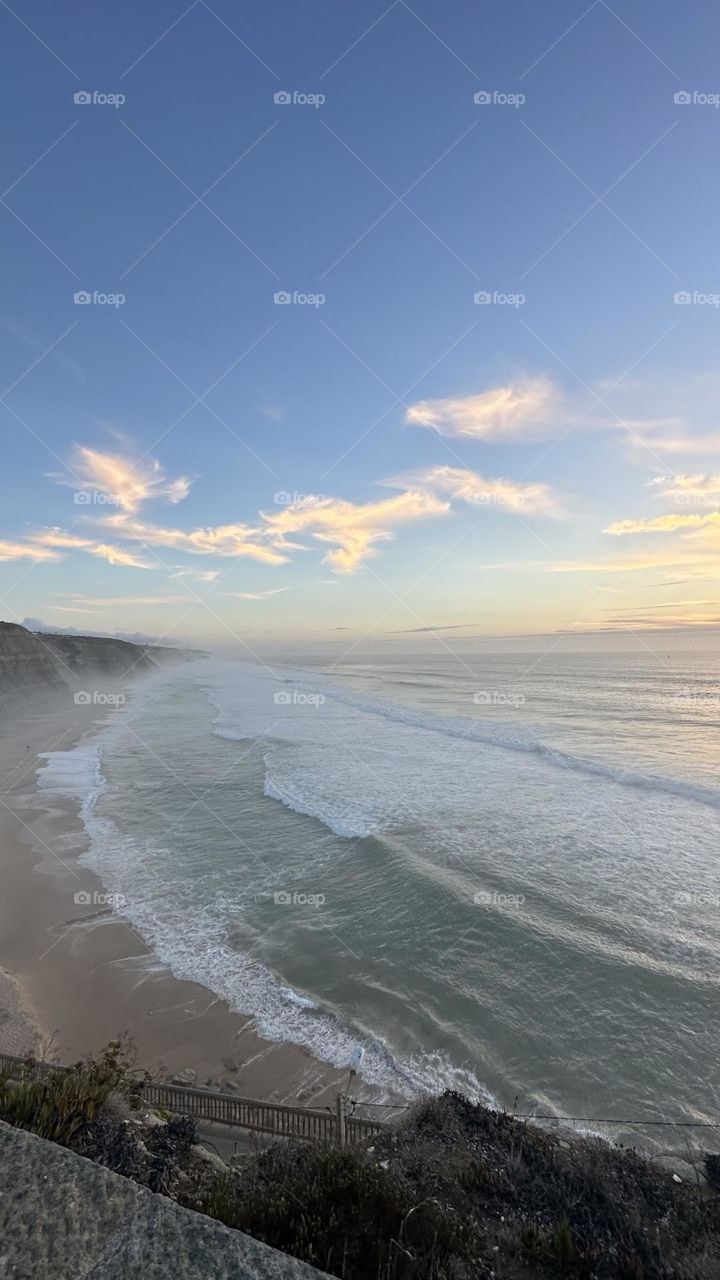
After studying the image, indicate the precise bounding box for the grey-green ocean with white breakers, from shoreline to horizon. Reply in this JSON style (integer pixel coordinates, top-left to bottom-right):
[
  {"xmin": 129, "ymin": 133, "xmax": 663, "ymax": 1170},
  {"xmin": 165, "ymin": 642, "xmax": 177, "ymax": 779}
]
[{"xmin": 40, "ymin": 652, "xmax": 720, "ymax": 1144}]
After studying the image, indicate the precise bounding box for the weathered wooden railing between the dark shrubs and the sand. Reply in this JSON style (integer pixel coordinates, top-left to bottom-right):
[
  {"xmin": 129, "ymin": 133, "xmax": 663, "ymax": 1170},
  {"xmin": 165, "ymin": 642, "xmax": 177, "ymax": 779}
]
[{"xmin": 0, "ymin": 1053, "xmax": 386, "ymax": 1146}]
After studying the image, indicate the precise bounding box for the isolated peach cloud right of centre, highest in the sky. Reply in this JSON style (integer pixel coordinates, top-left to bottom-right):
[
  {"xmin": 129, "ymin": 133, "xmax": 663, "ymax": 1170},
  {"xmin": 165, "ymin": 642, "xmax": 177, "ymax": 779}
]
[{"xmin": 405, "ymin": 378, "xmax": 558, "ymax": 442}]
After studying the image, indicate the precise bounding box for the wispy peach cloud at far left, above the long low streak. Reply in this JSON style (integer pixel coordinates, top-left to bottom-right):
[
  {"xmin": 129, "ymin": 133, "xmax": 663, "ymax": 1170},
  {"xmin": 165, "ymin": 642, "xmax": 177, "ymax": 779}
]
[{"xmin": 53, "ymin": 444, "xmax": 190, "ymax": 512}]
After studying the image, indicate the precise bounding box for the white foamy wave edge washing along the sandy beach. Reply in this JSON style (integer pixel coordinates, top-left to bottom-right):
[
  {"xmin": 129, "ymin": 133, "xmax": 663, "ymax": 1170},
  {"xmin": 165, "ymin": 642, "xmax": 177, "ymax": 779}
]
[{"xmin": 33, "ymin": 740, "xmax": 497, "ymax": 1106}]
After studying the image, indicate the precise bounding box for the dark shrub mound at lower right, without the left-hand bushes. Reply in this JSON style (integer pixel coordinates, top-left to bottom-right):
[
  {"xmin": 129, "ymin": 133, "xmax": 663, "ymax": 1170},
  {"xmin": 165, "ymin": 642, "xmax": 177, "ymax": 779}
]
[{"xmin": 204, "ymin": 1093, "xmax": 720, "ymax": 1280}]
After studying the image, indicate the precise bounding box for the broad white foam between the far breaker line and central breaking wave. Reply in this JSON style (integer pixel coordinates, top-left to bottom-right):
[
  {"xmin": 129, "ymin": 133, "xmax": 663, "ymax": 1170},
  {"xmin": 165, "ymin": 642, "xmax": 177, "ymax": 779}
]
[{"xmin": 199, "ymin": 663, "xmax": 720, "ymax": 838}]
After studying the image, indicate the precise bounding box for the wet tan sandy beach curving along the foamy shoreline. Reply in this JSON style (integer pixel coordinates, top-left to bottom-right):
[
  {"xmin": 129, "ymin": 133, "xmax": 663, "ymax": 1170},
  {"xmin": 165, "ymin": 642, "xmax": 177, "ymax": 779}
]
[{"xmin": 0, "ymin": 686, "xmax": 347, "ymax": 1105}]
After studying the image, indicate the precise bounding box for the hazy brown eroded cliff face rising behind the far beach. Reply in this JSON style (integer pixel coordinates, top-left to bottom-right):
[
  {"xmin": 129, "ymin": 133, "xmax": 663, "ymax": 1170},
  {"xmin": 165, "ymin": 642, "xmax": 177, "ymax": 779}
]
[{"xmin": 0, "ymin": 622, "xmax": 193, "ymax": 712}]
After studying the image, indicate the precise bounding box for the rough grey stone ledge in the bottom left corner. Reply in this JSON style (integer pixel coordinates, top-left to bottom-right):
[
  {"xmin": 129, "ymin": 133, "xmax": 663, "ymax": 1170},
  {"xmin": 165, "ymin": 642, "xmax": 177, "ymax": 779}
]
[{"xmin": 0, "ymin": 1121, "xmax": 322, "ymax": 1280}]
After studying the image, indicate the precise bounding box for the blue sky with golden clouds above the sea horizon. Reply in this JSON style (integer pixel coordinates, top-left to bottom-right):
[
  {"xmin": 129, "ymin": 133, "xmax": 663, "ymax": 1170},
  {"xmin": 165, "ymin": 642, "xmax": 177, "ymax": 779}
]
[{"xmin": 0, "ymin": 0, "xmax": 720, "ymax": 652}]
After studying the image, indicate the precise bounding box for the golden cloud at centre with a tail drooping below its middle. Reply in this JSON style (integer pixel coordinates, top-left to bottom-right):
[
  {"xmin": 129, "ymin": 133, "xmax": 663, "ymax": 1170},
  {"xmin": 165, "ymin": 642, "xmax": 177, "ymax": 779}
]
[{"xmin": 257, "ymin": 490, "xmax": 450, "ymax": 573}]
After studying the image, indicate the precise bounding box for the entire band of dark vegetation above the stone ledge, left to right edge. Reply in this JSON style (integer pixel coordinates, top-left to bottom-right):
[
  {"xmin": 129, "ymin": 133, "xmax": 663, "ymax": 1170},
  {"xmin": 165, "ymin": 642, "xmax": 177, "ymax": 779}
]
[{"xmin": 0, "ymin": 1042, "xmax": 720, "ymax": 1280}]
